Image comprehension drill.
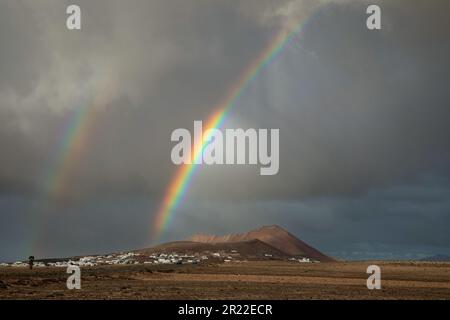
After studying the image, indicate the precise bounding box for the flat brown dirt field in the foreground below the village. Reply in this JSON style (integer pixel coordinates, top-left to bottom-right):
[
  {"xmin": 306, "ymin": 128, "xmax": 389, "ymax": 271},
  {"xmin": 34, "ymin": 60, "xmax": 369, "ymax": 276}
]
[{"xmin": 0, "ymin": 261, "xmax": 450, "ymax": 299}]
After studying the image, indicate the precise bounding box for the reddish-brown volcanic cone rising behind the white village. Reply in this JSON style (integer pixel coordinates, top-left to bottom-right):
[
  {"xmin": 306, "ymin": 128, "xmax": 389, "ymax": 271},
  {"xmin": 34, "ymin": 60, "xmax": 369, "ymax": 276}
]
[{"xmin": 188, "ymin": 226, "xmax": 335, "ymax": 262}]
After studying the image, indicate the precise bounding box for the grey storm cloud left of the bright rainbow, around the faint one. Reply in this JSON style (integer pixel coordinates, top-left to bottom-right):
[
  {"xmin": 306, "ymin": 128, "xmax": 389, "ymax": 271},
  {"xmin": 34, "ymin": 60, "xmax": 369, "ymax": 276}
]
[{"xmin": 0, "ymin": 1, "xmax": 284, "ymax": 197}]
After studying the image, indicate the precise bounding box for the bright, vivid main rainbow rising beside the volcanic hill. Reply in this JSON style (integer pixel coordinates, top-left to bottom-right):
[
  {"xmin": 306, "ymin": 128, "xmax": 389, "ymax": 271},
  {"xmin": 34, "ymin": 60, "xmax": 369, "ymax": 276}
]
[{"xmin": 152, "ymin": 20, "xmax": 304, "ymax": 240}]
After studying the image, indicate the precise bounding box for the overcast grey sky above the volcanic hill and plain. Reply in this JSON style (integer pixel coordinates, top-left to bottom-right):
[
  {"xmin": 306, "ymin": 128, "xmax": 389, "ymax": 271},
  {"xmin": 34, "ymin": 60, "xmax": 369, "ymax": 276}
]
[{"xmin": 0, "ymin": 0, "xmax": 450, "ymax": 261}]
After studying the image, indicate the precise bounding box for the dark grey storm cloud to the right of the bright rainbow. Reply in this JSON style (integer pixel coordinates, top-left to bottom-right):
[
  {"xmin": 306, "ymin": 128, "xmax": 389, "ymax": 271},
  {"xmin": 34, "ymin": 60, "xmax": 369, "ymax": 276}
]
[{"xmin": 192, "ymin": 2, "xmax": 450, "ymax": 198}]
